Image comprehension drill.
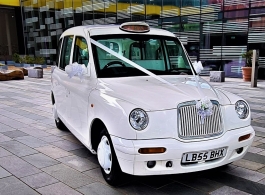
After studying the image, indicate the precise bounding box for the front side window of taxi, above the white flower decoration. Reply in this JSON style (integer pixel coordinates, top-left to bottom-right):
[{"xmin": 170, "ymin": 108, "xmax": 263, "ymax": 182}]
[{"xmin": 73, "ymin": 37, "xmax": 89, "ymax": 66}]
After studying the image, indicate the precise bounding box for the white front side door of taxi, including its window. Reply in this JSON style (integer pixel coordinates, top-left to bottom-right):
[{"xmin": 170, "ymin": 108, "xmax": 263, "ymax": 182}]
[{"xmin": 68, "ymin": 36, "xmax": 96, "ymax": 142}]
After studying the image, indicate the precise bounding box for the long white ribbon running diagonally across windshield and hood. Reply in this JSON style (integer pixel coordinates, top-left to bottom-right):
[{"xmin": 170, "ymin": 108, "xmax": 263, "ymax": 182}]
[{"xmin": 90, "ymin": 38, "xmax": 190, "ymax": 96}]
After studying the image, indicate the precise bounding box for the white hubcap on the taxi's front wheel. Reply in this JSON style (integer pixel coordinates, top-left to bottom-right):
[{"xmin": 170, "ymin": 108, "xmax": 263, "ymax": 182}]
[{"xmin": 97, "ymin": 135, "xmax": 112, "ymax": 174}]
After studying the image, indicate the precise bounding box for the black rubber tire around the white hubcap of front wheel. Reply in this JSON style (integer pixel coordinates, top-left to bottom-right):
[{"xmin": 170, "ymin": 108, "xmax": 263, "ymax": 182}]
[{"xmin": 99, "ymin": 128, "xmax": 125, "ymax": 186}]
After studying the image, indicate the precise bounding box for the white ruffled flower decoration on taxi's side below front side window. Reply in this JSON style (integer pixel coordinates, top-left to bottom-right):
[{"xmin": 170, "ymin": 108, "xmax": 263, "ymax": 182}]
[{"xmin": 65, "ymin": 62, "xmax": 88, "ymax": 79}]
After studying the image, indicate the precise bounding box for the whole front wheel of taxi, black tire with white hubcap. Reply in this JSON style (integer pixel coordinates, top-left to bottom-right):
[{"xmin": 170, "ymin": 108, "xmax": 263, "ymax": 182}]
[{"xmin": 97, "ymin": 129, "xmax": 124, "ymax": 186}]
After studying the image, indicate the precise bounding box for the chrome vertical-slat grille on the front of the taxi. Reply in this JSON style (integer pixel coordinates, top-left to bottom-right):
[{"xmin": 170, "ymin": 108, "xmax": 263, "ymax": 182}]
[{"xmin": 178, "ymin": 100, "xmax": 223, "ymax": 139}]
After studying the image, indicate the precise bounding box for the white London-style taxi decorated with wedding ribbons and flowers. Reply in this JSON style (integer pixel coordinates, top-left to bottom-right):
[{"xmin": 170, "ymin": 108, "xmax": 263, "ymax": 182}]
[{"xmin": 51, "ymin": 22, "xmax": 255, "ymax": 185}]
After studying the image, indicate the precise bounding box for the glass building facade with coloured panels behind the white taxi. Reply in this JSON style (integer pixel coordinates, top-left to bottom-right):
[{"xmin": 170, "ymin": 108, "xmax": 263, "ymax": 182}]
[{"xmin": 21, "ymin": 0, "xmax": 265, "ymax": 79}]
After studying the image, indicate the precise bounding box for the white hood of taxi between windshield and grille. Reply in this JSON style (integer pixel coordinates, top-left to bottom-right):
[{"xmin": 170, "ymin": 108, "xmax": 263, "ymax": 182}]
[{"xmin": 98, "ymin": 75, "xmax": 230, "ymax": 111}]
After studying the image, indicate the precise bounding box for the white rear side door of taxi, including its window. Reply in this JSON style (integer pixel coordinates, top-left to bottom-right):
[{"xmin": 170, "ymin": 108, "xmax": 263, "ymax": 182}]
[{"xmin": 53, "ymin": 36, "xmax": 74, "ymax": 124}]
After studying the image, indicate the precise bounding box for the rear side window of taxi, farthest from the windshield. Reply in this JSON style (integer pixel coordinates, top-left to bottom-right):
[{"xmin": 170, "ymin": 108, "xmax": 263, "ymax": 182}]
[{"xmin": 59, "ymin": 36, "xmax": 74, "ymax": 70}]
